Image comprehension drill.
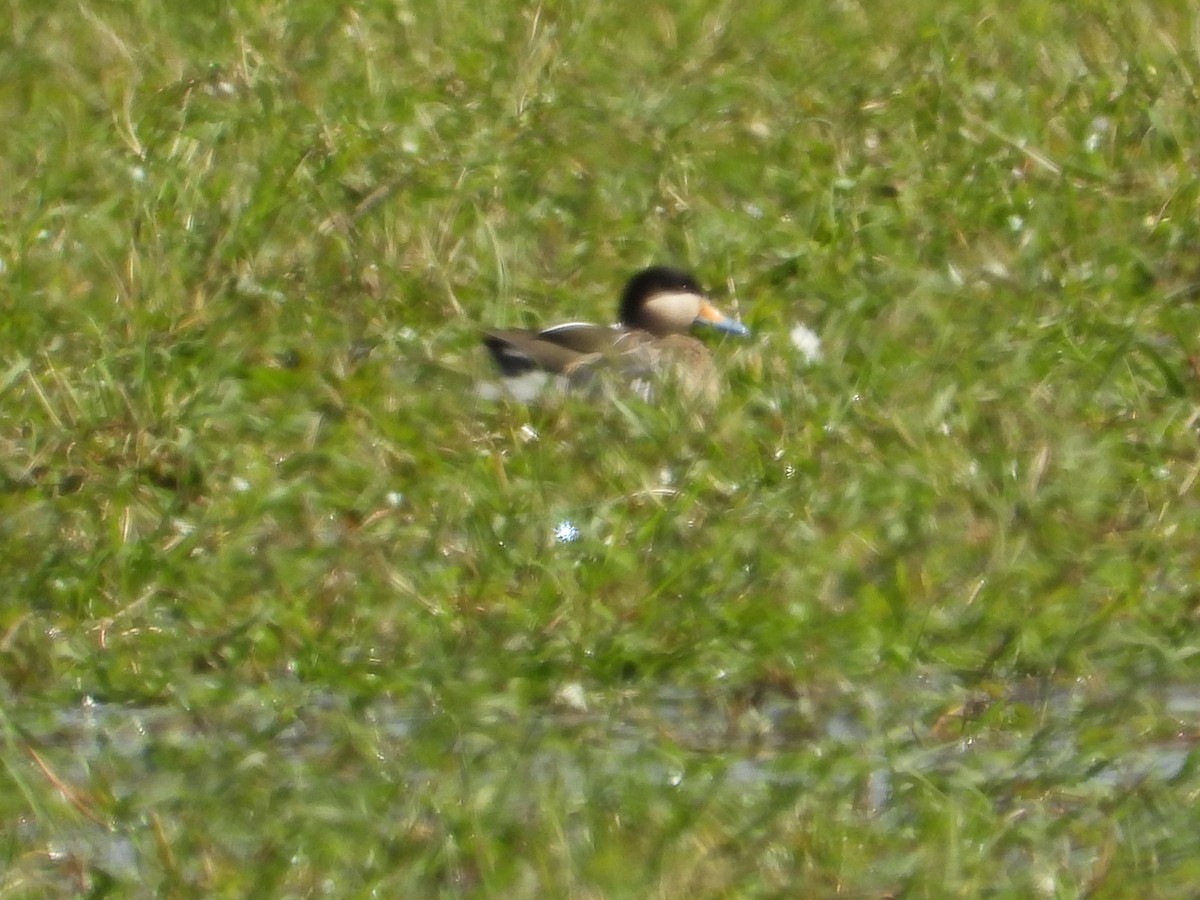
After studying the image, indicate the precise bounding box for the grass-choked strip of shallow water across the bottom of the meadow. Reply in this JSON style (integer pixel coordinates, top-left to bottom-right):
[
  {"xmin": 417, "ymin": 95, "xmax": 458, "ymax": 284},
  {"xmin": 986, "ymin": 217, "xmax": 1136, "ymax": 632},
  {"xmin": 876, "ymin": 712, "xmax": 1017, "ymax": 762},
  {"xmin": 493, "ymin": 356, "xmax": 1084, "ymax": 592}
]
[{"xmin": 18, "ymin": 678, "xmax": 1200, "ymax": 881}]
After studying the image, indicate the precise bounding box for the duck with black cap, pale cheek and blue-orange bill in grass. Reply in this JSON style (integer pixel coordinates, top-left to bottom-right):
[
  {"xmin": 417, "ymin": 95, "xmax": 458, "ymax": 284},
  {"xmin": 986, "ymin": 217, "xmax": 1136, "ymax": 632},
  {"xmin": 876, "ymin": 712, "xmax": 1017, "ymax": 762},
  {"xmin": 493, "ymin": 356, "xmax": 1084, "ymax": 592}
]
[{"xmin": 482, "ymin": 265, "xmax": 750, "ymax": 400}]
